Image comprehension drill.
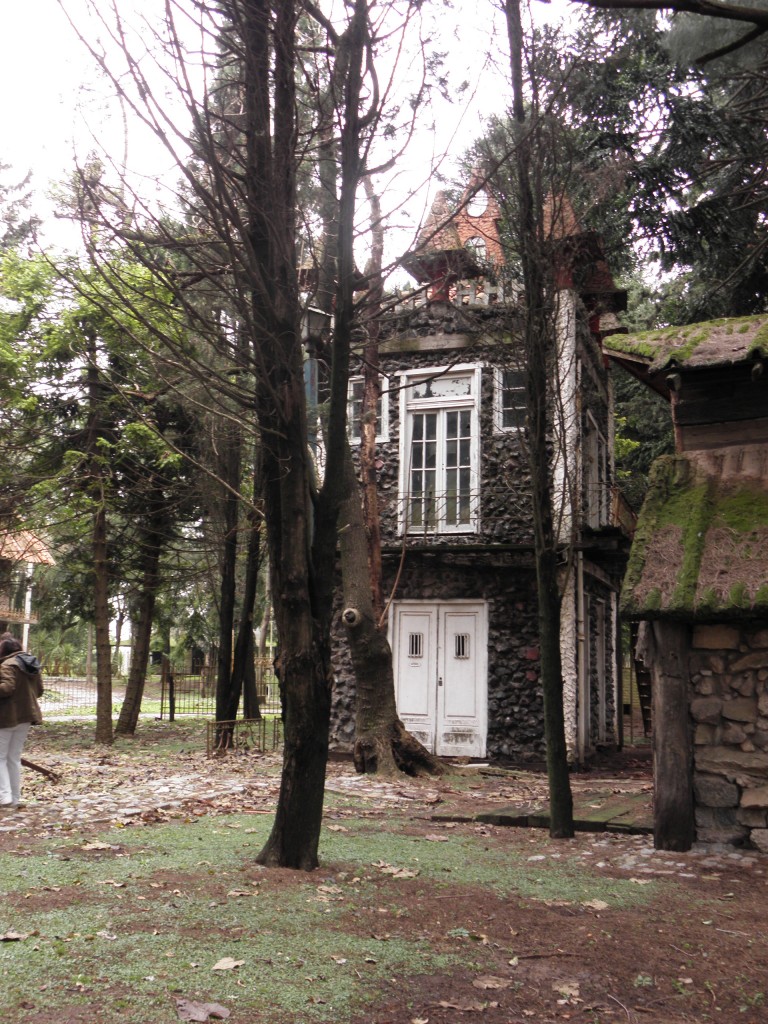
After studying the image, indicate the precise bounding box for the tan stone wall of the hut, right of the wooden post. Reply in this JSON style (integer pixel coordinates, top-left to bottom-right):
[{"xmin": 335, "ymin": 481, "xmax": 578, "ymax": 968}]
[{"xmin": 689, "ymin": 624, "xmax": 768, "ymax": 853}]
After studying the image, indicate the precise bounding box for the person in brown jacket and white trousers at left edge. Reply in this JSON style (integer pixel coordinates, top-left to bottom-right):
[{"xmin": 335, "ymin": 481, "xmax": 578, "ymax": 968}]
[{"xmin": 0, "ymin": 633, "xmax": 43, "ymax": 814}]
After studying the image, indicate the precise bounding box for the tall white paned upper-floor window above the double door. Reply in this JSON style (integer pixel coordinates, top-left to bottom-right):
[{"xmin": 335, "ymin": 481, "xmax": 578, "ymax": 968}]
[{"xmin": 400, "ymin": 367, "xmax": 480, "ymax": 534}]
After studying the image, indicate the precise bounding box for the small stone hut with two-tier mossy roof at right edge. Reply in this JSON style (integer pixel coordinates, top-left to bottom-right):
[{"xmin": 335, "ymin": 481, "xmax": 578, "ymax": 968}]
[{"xmin": 606, "ymin": 316, "xmax": 768, "ymax": 852}]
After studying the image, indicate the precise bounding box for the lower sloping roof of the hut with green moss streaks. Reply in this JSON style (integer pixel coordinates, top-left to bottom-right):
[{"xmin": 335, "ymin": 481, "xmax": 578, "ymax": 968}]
[{"xmin": 622, "ymin": 444, "xmax": 768, "ymax": 622}]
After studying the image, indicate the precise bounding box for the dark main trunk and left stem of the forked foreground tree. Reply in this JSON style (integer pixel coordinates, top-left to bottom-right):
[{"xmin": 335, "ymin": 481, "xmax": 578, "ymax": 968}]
[{"xmin": 237, "ymin": 0, "xmax": 336, "ymax": 870}]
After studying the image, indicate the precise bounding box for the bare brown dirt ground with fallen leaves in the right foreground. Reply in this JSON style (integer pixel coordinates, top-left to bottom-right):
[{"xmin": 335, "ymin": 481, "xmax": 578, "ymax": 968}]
[{"xmin": 333, "ymin": 751, "xmax": 768, "ymax": 1024}]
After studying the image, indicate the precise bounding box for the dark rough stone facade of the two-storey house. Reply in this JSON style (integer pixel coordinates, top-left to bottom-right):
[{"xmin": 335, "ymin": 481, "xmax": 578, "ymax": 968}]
[{"xmin": 331, "ymin": 292, "xmax": 623, "ymax": 762}]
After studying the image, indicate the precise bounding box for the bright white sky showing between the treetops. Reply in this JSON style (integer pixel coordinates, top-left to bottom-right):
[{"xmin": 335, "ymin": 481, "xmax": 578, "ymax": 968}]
[{"xmin": 0, "ymin": 0, "xmax": 566, "ymax": 256}]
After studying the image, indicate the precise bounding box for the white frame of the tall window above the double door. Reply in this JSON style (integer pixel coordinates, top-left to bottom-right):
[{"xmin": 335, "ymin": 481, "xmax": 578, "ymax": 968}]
[{"xmin": 398, "ymin": 364, "xmax": 481, "ymax": 536}]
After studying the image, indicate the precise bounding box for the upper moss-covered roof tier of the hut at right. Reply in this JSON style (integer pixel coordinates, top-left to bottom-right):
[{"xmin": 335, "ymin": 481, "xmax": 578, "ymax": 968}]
[{"xmin": 604, "ymin": 316, "xmax": 768, "ymax": 374}]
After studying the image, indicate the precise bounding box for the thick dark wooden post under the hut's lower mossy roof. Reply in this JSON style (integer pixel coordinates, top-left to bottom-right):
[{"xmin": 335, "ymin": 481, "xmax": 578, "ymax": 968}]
[{"xmin": 652, "ymin": 622, "xmax": 695, "ymax": 850}]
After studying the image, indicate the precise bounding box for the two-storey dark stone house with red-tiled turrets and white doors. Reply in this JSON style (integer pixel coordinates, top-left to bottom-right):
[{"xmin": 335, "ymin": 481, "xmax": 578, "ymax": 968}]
[{"xmin": 332, "ymin": 182, "xmax": 628, "ymax": 762}]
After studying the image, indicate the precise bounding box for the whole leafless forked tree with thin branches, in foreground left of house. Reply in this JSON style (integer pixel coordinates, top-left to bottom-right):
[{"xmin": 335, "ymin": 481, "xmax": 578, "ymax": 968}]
[{"xmin": 62, "ymin": 0, "xmax": 436, "ymax": 869}]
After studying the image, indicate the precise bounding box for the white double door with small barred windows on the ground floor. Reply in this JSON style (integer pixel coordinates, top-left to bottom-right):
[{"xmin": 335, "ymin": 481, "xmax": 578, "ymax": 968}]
[{"xmin": 391, "ymin": 601, "xmax": 487, "ymax": 757}]
